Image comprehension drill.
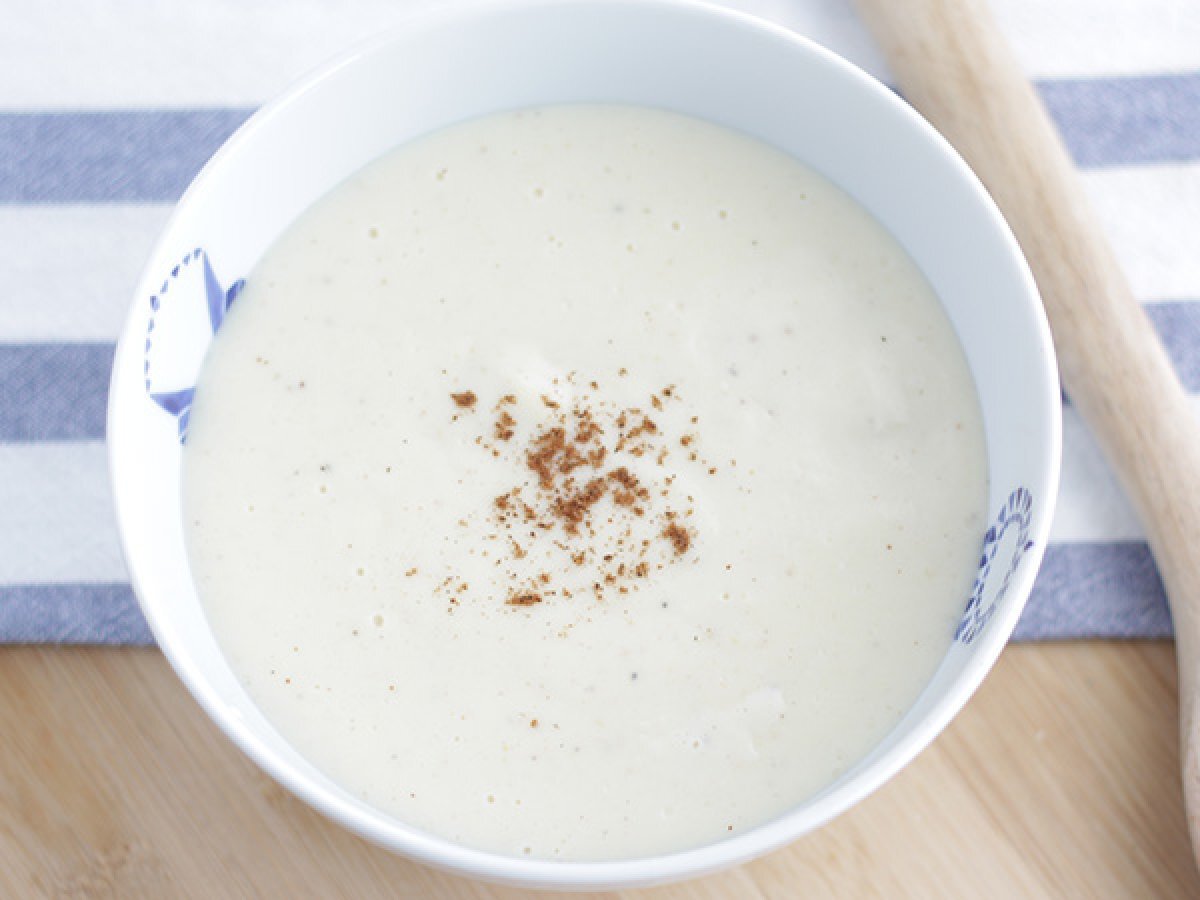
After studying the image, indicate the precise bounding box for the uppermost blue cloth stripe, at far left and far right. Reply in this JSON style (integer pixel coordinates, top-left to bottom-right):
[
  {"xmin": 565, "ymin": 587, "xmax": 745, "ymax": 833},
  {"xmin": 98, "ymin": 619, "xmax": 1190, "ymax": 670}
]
[{"xmin": 0, "ymin": 73, "xmax": 1200, "ymax": 204}]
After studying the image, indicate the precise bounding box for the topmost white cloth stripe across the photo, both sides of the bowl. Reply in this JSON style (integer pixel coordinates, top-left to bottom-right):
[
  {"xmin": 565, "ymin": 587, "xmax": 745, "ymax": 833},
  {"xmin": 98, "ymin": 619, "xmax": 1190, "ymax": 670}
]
[{"xmin": 0, "ymin": 0, "xmax": 1200, "ymax": 109}]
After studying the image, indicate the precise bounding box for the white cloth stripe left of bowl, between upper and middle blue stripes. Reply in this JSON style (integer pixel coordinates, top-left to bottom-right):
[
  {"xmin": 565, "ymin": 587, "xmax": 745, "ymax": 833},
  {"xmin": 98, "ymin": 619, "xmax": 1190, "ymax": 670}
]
[{"xmin": 0, "ymin": 206, "xmax": 170, "ymax": 342}]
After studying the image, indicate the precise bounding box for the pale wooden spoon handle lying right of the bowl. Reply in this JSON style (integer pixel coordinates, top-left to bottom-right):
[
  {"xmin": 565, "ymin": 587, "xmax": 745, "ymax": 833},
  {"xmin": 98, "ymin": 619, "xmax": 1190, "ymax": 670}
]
[{"xmin": 858, "ymin": 0, "xmax": 1200, "ymax": 852}]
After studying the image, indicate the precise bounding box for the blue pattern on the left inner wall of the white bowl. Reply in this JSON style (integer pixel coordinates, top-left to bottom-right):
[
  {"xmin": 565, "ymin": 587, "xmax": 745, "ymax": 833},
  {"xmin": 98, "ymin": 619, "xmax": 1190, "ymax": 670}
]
[{"xmin": 143, "ymin": 247, "xmax": 245, "ymax": 442}]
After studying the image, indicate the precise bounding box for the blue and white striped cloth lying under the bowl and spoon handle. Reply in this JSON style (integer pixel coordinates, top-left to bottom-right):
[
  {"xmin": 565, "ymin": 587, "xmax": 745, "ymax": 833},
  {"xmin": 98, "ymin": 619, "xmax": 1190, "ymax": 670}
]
[{"xmin": 0, "ymin": 0, "xmax": 1200, "ymax": 643}]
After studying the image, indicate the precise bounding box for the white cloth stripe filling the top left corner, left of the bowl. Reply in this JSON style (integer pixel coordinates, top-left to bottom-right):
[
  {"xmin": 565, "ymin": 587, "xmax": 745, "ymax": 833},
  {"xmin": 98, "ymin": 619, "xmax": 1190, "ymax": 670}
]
[{"xmin": 0, "ymin": 0, "xmax": 433, "ymax": 109}]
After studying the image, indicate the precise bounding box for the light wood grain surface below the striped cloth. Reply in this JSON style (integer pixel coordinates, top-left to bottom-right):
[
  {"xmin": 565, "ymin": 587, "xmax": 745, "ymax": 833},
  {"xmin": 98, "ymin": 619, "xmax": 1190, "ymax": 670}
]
[{"xmin": 0, "ymin": 642, "xmax": 1200, "ymax": 900}]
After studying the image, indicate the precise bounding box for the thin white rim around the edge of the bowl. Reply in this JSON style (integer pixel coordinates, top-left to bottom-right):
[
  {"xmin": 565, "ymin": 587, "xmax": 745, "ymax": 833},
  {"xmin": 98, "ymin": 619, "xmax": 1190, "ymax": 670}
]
[{"xmin": 107, "ymin": 0, "xmax": 1062, "ymax": 889}]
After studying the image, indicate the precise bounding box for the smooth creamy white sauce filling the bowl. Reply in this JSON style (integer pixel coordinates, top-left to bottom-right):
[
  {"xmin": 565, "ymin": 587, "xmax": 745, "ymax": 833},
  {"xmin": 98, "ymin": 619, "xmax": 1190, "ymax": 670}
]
[{"xmin": 184, "ymin": 106, "xmax": 986, "ymax": 859}]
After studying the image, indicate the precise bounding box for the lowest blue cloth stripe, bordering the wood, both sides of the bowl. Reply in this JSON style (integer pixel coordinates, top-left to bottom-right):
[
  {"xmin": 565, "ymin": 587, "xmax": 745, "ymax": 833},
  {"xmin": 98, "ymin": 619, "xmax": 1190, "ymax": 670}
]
[{"xmin": 0, "ymin": 542, "xmax": 1171, "ymax": 644}]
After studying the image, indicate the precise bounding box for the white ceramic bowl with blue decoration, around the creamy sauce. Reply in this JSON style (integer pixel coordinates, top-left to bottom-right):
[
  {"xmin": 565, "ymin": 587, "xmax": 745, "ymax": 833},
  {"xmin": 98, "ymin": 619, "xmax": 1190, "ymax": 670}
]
[{"xmin": 108, "ymin": 0, "xmax": 1060, "ymax": 888}]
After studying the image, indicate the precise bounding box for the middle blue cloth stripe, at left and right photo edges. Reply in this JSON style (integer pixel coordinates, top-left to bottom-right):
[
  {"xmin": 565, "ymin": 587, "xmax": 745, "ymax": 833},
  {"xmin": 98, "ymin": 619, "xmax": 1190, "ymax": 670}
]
[{"xmin": 0, "ymin": 300, "xmax": 1200, "ymax": 443}]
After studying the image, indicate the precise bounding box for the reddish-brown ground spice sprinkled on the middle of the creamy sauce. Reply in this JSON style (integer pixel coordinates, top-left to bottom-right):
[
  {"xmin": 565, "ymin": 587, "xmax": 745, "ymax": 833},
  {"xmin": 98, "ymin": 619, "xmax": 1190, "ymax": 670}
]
[{"xmin": 444, "ymin": 374, "xmax": 718, "ymax": 607}]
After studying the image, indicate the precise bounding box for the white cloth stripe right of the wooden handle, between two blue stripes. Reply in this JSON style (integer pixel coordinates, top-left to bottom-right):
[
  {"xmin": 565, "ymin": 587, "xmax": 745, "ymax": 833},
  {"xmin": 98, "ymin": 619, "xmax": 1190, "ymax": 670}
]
[{"xmin": 1084, "ymin": 164, "xmax": 1200, "ymax": 299}]
